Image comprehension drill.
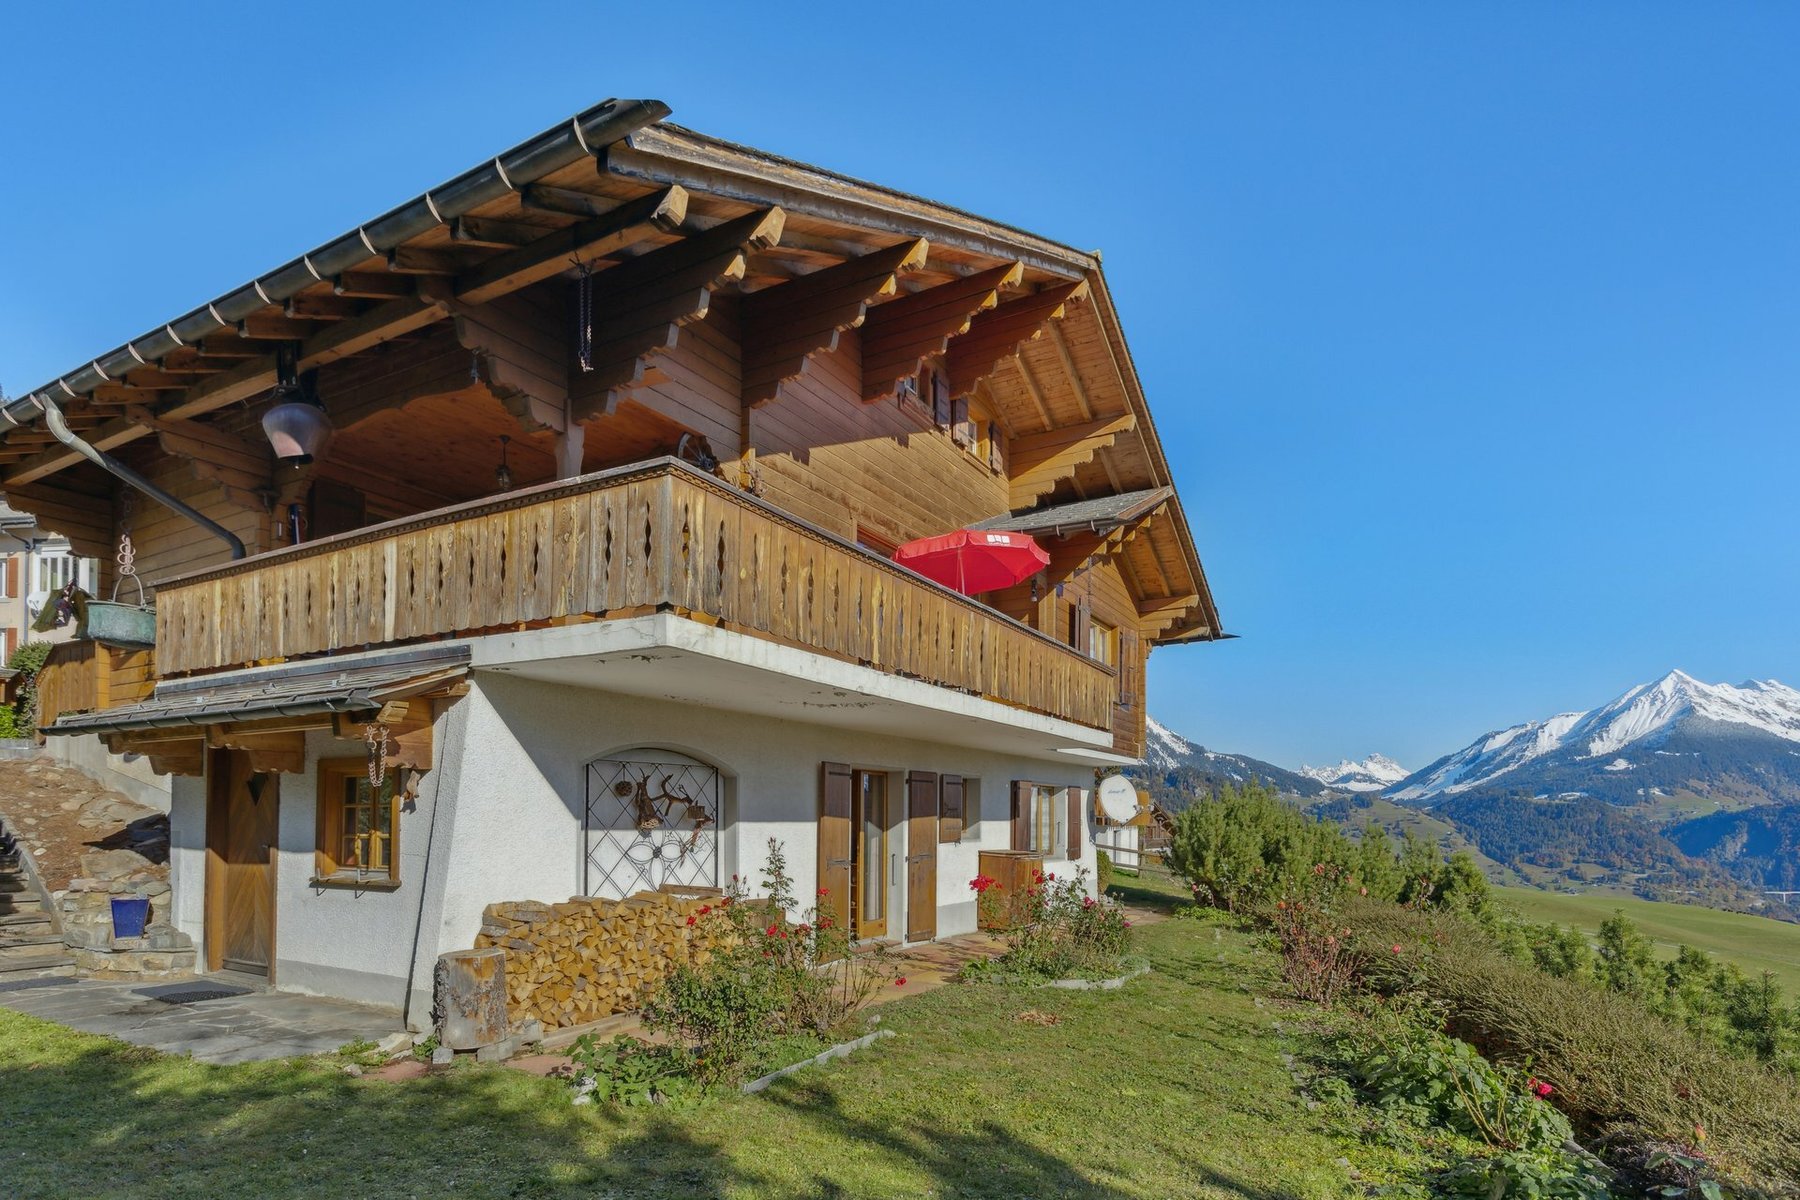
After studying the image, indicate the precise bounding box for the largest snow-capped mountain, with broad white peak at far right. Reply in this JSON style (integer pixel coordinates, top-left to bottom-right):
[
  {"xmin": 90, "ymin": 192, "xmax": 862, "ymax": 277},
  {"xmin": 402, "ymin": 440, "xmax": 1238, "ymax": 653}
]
[{"xmin": 1388, "ymin": 671, "xmax": 1800, "ymax": 806}]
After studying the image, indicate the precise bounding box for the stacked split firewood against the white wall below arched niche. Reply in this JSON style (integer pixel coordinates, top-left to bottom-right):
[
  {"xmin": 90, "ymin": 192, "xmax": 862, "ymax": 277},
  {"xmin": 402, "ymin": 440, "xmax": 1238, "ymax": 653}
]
[{"xmin": 475, "ymin": 889, "xmax": 729, "ymax": 1029}]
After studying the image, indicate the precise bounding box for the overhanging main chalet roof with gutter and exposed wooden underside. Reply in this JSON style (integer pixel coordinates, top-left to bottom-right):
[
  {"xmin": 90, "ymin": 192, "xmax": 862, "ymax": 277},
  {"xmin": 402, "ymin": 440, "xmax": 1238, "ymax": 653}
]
[{"xmin": 0, "ymin": 99, "xmax": 1220, "ymax": 637}]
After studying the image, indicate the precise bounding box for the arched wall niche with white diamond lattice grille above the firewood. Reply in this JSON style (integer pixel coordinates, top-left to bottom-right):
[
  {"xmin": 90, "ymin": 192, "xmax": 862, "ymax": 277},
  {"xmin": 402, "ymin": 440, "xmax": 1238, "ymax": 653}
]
[{"xmin": 583, "ymin": 747, "xmax": 724, "ymax": 900}]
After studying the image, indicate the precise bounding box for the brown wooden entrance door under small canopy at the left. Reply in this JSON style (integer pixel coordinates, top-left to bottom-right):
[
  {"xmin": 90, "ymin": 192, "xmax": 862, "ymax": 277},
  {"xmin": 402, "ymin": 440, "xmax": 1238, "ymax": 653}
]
[{"xmin": 207, "ymin": 750, "xmax": 279, "ymax": 975}]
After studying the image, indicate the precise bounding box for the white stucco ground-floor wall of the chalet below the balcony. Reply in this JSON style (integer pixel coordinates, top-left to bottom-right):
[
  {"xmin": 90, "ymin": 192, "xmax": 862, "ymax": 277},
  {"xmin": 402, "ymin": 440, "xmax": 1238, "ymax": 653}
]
[{"xmin": 171, "ymin": 671, "xmax": 1094, "ymax": 1027}]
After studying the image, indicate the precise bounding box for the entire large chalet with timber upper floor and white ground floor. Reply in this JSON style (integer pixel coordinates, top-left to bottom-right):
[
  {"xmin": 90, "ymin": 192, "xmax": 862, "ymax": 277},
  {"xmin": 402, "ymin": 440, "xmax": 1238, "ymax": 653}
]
[{"xmin": 0, "ymin": 101, "xmax": 1220, "ymax": 1024}]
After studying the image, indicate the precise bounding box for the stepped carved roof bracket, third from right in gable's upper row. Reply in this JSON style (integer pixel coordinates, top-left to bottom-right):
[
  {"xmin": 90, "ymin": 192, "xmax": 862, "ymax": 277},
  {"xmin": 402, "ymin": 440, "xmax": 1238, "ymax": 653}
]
[{"xmin": 742, "ymin": 237, "xmax": 929, "ymax": 408}]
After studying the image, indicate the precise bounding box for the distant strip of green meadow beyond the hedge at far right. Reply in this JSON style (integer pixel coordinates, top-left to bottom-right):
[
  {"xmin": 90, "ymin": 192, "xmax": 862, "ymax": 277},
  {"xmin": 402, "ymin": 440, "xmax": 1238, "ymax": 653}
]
[{"xmin": 1496, "ymin": 887, "xmax": 1800, "ymax": 995}]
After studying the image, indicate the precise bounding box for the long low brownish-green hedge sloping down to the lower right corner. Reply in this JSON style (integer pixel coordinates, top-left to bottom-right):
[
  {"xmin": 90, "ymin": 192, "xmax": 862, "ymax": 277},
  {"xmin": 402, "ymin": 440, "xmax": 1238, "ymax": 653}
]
[{"xmin": 1352, "ymin": 905, "xmax": 1800, "ymax": 1193}]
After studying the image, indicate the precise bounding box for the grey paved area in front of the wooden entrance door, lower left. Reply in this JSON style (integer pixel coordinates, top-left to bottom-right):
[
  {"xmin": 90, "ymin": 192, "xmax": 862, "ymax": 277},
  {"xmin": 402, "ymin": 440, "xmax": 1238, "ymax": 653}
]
[{"xmin": 0, "ymin": 977, "xmax": 401, "ymax": 1063}]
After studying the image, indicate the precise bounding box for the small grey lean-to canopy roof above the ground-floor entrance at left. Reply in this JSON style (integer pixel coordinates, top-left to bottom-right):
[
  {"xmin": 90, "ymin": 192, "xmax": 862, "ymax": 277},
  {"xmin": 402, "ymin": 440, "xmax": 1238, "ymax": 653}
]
[{"xmin": 43, "ymin": 646, "xmax": 468, "ymax": 734}]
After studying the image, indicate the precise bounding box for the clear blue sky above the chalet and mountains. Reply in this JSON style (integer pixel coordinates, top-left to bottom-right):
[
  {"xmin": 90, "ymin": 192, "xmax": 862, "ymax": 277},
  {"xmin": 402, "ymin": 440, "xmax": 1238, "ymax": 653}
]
[{"xmin": 0, "ymin": 0, "xmax": 1800, "ymax": 766}]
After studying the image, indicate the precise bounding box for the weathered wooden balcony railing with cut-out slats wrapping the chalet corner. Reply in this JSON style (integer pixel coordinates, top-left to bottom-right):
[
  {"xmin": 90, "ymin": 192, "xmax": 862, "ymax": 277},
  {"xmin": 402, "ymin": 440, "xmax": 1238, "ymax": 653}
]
[{"xmin": 157, "ymin": 459, "xmax": 1118, "ymax": 730}]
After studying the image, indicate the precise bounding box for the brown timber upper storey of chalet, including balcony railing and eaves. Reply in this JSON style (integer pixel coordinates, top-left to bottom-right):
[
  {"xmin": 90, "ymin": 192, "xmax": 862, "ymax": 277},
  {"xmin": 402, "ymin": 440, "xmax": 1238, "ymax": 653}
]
[{"xmin": 0, "ymin": 100, "xmax": 1220, "ymax": 754}]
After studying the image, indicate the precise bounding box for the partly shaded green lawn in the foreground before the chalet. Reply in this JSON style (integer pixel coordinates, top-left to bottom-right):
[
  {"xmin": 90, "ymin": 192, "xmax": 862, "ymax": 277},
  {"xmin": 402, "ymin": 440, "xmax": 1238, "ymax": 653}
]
[{"xmin": 0, "ymin": 906, "xmax": 1404, "ymax": 1200}]
